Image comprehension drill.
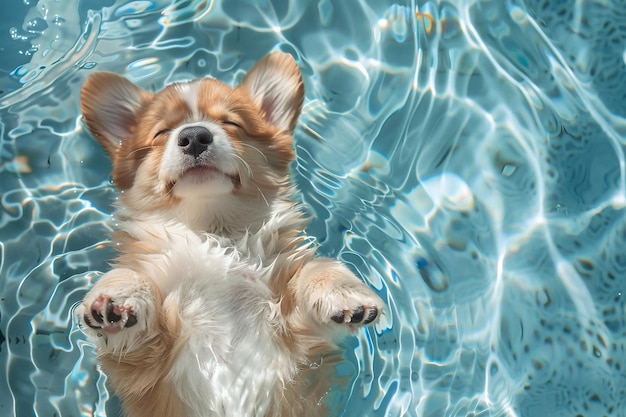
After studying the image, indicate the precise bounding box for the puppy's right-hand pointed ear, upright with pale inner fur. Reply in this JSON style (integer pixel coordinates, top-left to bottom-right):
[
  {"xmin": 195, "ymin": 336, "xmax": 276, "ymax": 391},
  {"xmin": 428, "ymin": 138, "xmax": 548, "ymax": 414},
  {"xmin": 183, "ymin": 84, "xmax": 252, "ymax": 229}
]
[{"xmin": 241, "ymin": 52, "xmax": 304, "ymax": 133}]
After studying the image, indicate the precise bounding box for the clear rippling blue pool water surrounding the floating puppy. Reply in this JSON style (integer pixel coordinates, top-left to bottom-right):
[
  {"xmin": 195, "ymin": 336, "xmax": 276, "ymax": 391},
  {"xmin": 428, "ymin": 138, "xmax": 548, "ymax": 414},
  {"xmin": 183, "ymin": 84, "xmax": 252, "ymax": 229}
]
[{"xmin": 0, "ymin": 0, "xmax": 626, "ymax": 417}]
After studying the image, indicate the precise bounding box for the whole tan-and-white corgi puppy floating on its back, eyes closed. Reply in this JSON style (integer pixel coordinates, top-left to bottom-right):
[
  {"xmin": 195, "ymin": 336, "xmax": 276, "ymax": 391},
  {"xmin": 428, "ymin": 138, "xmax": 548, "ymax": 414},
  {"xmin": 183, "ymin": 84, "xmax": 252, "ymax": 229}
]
[{"xmin": 78, "ymin": 52, "xmax": 383, "ymax": 417}]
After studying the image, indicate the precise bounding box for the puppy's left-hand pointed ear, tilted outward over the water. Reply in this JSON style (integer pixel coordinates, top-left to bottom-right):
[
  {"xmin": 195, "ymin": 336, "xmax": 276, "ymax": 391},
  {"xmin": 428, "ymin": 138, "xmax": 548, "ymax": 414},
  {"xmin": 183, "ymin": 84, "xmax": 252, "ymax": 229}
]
[{"xmin": 80, "ymin": 72, "xmax": 152, "ymax": 158}]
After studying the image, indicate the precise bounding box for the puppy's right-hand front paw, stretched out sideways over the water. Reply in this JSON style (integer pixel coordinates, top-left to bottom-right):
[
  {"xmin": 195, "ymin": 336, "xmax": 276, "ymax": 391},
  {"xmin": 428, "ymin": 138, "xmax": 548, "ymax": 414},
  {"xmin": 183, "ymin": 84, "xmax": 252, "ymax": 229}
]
[{"xmin": 290, "ymin": 258, "xmax": 383, "ymax": 330}]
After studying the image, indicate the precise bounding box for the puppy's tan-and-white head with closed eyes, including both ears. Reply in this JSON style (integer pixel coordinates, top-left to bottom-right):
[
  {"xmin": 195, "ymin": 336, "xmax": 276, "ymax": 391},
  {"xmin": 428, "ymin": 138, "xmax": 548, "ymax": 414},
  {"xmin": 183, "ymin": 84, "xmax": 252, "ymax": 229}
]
[{"xmin": 81, "ymin": 53, "xmax": 304, "ymax": 228}]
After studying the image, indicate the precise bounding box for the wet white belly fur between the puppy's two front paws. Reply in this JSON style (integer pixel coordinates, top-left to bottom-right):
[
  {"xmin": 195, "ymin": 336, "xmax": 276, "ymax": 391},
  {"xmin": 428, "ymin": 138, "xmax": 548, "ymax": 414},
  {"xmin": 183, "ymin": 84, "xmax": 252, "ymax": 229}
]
[{"xmin": 165, "ymin": 244, "xmax": 295, "ymax": 417}]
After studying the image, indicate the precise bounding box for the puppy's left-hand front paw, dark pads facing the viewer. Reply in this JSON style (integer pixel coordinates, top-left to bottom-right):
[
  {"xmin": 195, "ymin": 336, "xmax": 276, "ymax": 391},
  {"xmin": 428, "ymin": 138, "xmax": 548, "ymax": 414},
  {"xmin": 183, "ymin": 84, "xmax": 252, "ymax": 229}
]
[{"xmin": 77, "ymin": 268, "xmax": 161, "ymax": 352}]
